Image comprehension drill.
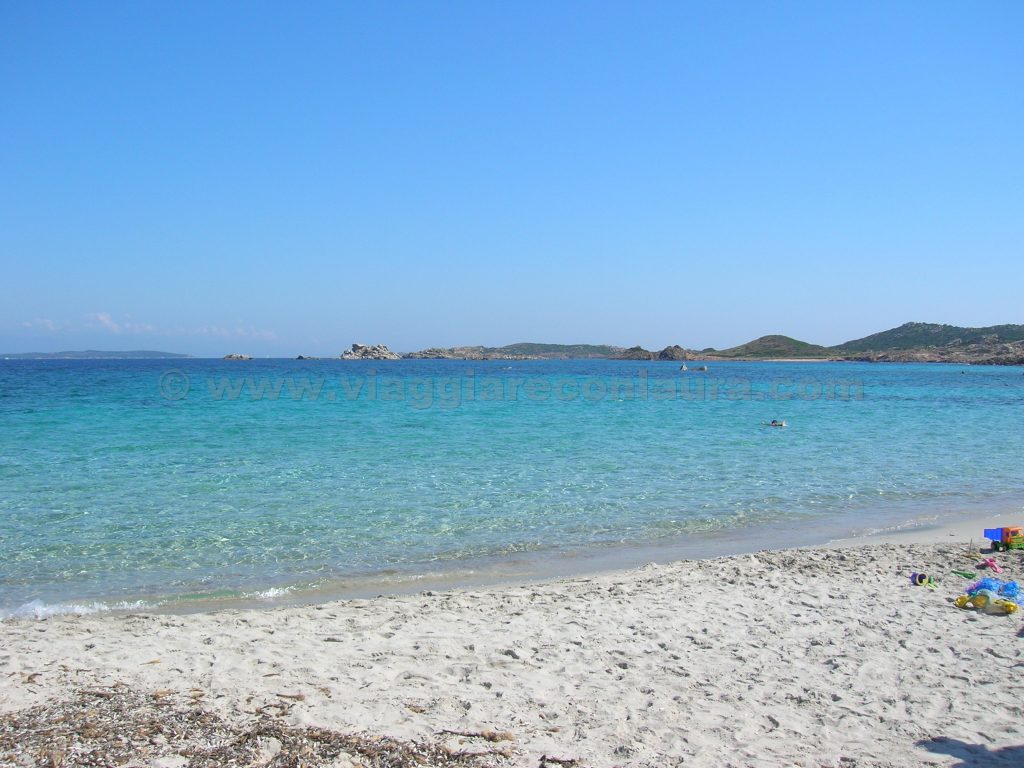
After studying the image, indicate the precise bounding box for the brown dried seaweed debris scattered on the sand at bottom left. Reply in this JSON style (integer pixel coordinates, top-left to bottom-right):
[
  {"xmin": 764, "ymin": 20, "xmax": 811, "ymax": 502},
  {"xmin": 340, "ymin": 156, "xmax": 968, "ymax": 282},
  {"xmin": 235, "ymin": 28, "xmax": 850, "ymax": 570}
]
[{"xmin": 0, "ymin": 686, "xmax": 536, "ymax": 768}]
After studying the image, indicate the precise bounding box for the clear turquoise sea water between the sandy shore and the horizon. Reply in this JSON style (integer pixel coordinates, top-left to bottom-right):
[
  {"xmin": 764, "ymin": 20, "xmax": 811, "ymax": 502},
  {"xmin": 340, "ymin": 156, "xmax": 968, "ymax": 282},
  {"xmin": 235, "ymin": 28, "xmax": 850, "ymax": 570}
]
[{"xmin": 0, "ymin": 360, "xmax": 1024, "ymax": 613}]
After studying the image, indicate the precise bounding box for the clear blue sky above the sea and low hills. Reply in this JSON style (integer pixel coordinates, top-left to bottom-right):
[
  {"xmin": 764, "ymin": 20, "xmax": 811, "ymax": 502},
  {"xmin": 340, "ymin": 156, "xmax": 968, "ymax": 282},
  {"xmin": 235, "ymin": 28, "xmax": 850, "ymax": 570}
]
[{"xmin": 0, "ymin": 0, "xmax": 1024, "ymax": 356}]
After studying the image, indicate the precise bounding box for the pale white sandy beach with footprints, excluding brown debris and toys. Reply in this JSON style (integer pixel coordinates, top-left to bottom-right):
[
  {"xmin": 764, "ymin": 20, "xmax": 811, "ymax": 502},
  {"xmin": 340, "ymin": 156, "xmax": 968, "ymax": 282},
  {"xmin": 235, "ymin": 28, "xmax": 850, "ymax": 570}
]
[{"xmin": 0, "ymin": 520, "xmax": 1024, "ymax": 768}]
